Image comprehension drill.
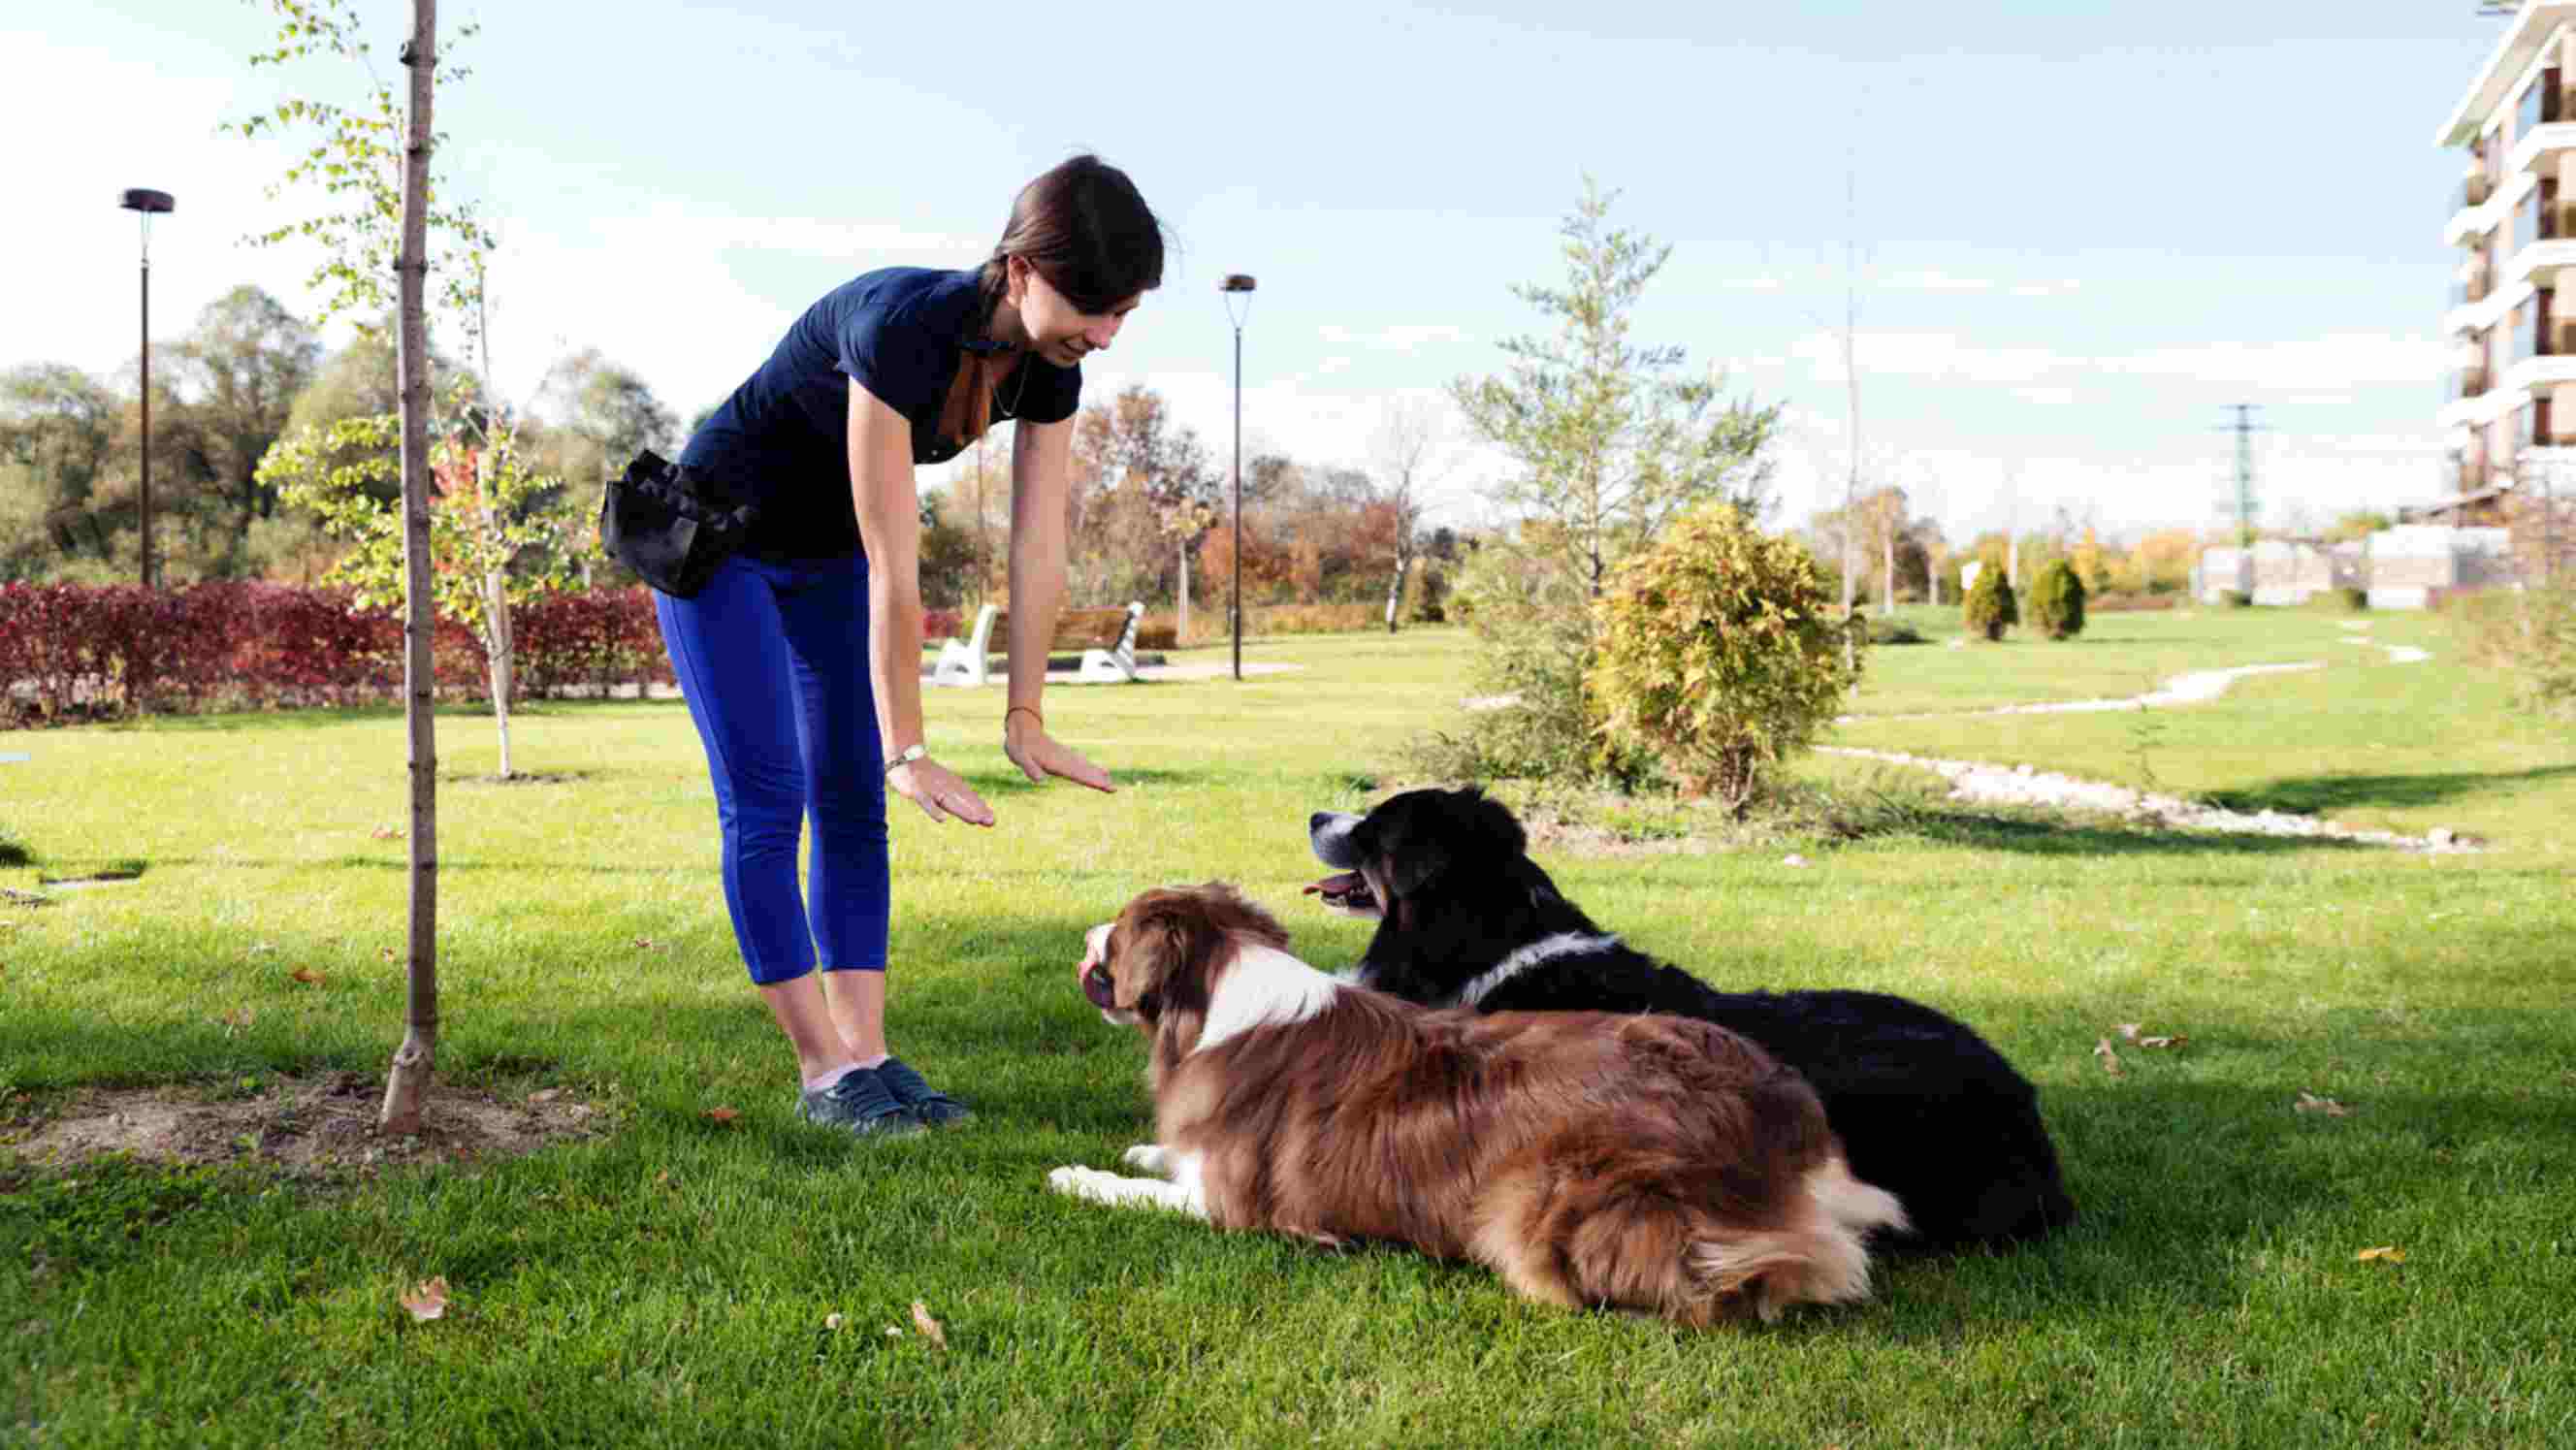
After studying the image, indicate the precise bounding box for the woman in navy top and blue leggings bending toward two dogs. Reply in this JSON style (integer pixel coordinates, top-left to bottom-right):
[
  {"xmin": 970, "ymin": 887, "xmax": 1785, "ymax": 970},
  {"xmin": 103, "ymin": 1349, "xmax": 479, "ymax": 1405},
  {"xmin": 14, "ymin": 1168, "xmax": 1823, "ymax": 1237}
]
[{"xmin": 655, "ymin": 154, "xmax": 1162, "ymax": 1133}]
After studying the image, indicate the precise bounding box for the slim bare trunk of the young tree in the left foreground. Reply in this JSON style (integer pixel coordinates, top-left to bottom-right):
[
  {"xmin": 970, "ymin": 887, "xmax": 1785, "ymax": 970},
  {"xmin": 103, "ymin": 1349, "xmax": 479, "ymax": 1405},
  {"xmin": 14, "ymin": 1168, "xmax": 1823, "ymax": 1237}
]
[{"xmin": 376, "ymin": 0, "xmax": 438, "ymax": 1133}]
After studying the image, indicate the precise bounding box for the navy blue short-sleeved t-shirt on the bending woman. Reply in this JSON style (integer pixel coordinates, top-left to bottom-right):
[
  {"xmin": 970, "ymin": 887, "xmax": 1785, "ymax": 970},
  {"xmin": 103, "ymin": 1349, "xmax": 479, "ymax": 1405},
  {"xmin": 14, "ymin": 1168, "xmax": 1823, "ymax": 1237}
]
[{"xmin": 680, "ymin": 268, "xmax": 1082, "ymax": 559}]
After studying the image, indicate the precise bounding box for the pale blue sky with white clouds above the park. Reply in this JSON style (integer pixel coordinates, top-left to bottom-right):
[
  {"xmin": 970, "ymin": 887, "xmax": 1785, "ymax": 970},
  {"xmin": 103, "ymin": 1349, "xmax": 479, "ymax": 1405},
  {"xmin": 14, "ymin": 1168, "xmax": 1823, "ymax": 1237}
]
[{"xmin": 0, "ymin": 0, "xmax": 2506, "ymax": 541}]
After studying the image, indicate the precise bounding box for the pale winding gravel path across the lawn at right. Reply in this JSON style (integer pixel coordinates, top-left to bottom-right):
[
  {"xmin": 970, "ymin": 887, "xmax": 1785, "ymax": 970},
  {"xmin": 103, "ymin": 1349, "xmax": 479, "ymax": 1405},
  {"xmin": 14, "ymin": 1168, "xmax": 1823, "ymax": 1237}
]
[{"xmin": 1816, "ymin": 641, "xmax": 2481, "ymax": 853}]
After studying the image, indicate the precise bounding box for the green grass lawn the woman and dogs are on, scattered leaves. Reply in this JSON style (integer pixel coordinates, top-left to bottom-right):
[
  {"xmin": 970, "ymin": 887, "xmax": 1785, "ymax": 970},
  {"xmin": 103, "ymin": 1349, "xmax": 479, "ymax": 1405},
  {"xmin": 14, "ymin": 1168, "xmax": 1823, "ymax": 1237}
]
[{"xmin": 0, "ymin": 610, "xmax": 2576, "ymax": 1447}]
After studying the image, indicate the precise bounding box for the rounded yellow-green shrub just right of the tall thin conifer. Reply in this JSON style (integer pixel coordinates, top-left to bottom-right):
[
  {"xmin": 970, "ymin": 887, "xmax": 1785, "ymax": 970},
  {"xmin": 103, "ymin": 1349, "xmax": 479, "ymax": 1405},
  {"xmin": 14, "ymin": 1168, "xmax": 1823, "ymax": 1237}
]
[{"xmin": 1584, "ymin": 504, "xmax": 1865, "ymax": 817}]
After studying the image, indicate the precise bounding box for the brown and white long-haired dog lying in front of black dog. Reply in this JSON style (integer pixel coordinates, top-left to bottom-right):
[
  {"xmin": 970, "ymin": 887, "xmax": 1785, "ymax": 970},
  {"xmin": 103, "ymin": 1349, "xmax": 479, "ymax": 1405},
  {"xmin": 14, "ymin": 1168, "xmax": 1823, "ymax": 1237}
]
[{"xmin": 1048, "ymin": 884, "xmax": 1904, "ymax": 1327}]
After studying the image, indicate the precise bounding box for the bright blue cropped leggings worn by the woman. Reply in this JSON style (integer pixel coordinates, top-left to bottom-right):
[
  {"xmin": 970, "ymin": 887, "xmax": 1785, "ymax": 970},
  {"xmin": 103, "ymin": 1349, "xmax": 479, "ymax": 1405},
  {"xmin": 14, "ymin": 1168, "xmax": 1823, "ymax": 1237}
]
[{"xmin": 655, "ymin": 554, "xmax": 891, "ymax": 986}]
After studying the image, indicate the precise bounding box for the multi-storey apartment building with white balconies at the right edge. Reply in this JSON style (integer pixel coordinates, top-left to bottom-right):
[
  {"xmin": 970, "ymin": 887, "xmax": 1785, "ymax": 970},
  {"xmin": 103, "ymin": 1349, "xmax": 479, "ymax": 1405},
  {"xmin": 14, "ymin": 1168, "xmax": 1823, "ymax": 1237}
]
[{"xmin": 2439, "ymin": 0, "xmax": 2576, "ymax": 523}]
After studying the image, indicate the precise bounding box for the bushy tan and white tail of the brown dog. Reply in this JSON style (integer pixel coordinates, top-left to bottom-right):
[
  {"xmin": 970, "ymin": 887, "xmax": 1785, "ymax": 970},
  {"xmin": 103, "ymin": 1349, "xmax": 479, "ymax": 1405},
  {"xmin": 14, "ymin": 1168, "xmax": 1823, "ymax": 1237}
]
[{"xmin": 1685, "ymin": 1154, "xmax": 1906, "ymax": 1321}]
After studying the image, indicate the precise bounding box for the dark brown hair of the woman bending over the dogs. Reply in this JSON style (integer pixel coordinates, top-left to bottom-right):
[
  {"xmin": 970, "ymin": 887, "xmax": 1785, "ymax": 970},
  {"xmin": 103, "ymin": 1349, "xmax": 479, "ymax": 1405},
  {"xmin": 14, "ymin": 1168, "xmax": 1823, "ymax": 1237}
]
[{"xmin": 940, "ymin": 154, "xmax": 1162, "ymax": 448}]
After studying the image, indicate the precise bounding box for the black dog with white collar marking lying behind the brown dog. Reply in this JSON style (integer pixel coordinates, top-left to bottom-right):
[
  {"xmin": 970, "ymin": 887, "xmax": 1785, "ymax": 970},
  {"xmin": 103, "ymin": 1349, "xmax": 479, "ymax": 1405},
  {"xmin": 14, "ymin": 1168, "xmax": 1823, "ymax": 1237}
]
[{"xmin": 1306, "ymin": 789, "xmax": 2077, "ymax": 1249}]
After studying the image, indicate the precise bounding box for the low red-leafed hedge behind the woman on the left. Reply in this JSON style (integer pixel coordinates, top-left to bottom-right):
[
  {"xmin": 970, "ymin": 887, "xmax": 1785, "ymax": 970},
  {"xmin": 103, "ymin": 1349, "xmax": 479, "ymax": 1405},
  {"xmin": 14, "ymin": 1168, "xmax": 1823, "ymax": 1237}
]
[{"xmin": 0, "ymin": 582, "xmax": 672, "ymax": 726}]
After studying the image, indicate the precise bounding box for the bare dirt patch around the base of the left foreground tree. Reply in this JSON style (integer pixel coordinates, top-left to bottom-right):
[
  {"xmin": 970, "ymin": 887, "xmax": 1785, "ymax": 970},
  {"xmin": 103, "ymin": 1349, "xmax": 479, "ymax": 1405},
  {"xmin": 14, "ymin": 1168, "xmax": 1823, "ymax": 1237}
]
[{"xmin": 0, "ymin": 1072, "xmax": 608, "ymax": 1179}]
